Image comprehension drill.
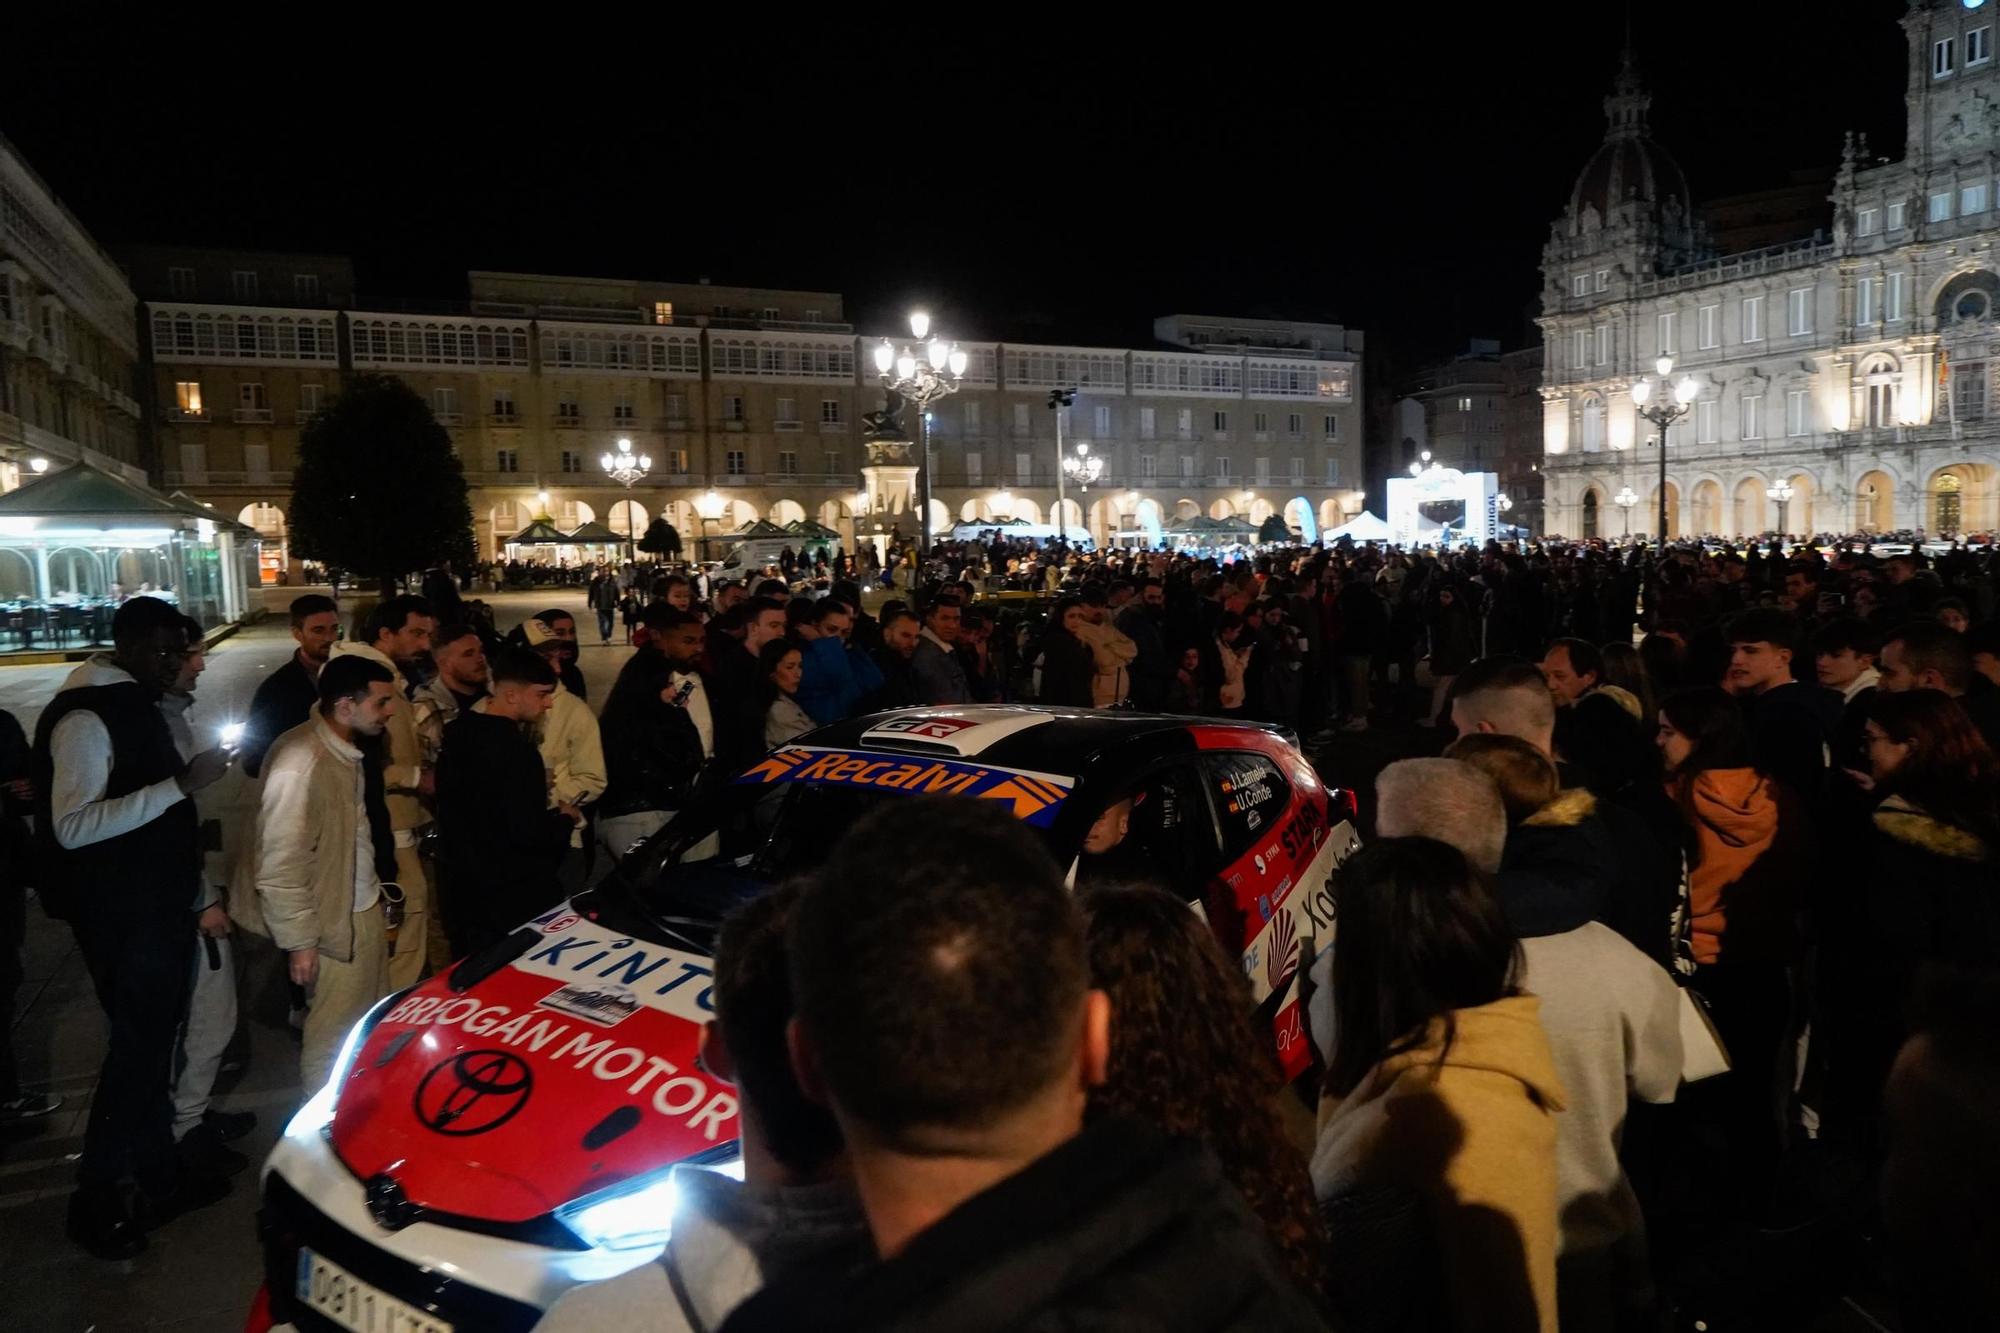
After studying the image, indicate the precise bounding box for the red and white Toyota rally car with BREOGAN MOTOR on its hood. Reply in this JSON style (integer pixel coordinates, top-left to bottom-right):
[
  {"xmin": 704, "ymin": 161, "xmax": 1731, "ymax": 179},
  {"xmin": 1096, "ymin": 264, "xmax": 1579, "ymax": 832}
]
[{"xmin": 250, "ymin": 707, "xmax": 1354, "ymax": 1333}]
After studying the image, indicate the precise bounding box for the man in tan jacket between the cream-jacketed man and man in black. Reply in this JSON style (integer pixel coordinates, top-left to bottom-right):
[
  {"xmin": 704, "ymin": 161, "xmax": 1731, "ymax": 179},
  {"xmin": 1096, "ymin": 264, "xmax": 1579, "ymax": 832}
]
[{"xmin": 330, "ymin": 596, "xmax": 436, "ymax": 991}]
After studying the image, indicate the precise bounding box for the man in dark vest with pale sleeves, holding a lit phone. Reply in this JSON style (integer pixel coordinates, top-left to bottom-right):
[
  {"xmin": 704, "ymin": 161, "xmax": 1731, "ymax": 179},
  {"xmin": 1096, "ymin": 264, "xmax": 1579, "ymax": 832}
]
[{"xmin": 34, "ymin": 596, "xmax": 230, "ymax": 1259}]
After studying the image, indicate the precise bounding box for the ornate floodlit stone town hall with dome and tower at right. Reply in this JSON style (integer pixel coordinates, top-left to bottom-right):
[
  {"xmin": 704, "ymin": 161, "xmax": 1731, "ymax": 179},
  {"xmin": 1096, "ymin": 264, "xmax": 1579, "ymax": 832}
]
[{"xmin": 1540, "ymin": 0, "xmax": 2000, "ymax": 536}]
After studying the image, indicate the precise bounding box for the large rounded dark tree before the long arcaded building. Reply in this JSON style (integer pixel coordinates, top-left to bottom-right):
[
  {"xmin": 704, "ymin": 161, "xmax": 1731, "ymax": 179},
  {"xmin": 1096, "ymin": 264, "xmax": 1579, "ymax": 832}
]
[{"xmin": 290, "ymin": 374, "xmax": 474, "ymax": 596}]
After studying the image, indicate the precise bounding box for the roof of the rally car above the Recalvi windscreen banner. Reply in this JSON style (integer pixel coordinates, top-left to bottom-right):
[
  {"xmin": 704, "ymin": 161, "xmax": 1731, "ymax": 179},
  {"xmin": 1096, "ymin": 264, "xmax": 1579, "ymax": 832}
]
[{"xmin": 794, "ymin": 705, "xmax": 1284, "ymax": 775}]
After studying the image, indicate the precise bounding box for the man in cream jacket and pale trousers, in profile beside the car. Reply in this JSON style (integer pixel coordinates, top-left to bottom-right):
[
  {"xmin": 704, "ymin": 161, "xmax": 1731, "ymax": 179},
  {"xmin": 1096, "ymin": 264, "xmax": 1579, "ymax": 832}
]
[{"xmin": 256, "ymin": 652, "xmax": 400, "ymax": 1089}]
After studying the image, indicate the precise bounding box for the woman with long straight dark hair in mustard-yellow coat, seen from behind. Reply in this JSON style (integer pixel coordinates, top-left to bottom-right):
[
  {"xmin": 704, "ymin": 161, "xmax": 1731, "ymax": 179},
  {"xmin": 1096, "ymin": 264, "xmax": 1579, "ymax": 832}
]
[{"xmin": 1312, "ymin": 839, "xmax": 1564, "ymax": 1331}]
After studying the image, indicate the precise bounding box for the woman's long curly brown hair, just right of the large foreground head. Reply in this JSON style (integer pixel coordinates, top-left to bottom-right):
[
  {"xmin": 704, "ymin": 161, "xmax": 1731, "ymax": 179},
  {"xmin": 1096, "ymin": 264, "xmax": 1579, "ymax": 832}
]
[{"xmin": 1082, "ymin": 887, "xmax": 1326, "ymax": 1299}]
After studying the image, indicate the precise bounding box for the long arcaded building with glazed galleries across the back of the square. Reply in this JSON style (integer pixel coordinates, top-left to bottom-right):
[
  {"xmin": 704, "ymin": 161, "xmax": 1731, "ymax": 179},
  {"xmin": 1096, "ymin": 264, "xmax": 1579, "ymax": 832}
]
[{"xmin": 130, "ymin": 250, "xmax": 1362, "ymax": 576}]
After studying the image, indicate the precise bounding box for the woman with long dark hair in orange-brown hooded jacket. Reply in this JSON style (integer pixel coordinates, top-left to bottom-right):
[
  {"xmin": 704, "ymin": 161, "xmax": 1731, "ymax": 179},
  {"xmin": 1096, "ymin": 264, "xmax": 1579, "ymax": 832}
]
[{"xmin": 1658, "ymin": 687, "xmax": 1810, "ymax": 1209}]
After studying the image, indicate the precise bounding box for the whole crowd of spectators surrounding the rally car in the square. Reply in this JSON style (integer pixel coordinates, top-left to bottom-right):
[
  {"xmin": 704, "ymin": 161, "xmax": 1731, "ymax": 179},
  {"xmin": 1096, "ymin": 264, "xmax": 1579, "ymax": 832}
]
[{"xmin": 0, "ymin": 524, "xmax": 2000, "ymax": 1333}]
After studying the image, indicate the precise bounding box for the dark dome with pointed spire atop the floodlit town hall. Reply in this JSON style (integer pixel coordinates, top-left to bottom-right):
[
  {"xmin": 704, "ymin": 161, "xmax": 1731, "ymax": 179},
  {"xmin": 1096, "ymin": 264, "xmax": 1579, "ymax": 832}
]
[{"xmin": 1542, "ymin": 48, "xmax": 1698, "ymax": 300}]
